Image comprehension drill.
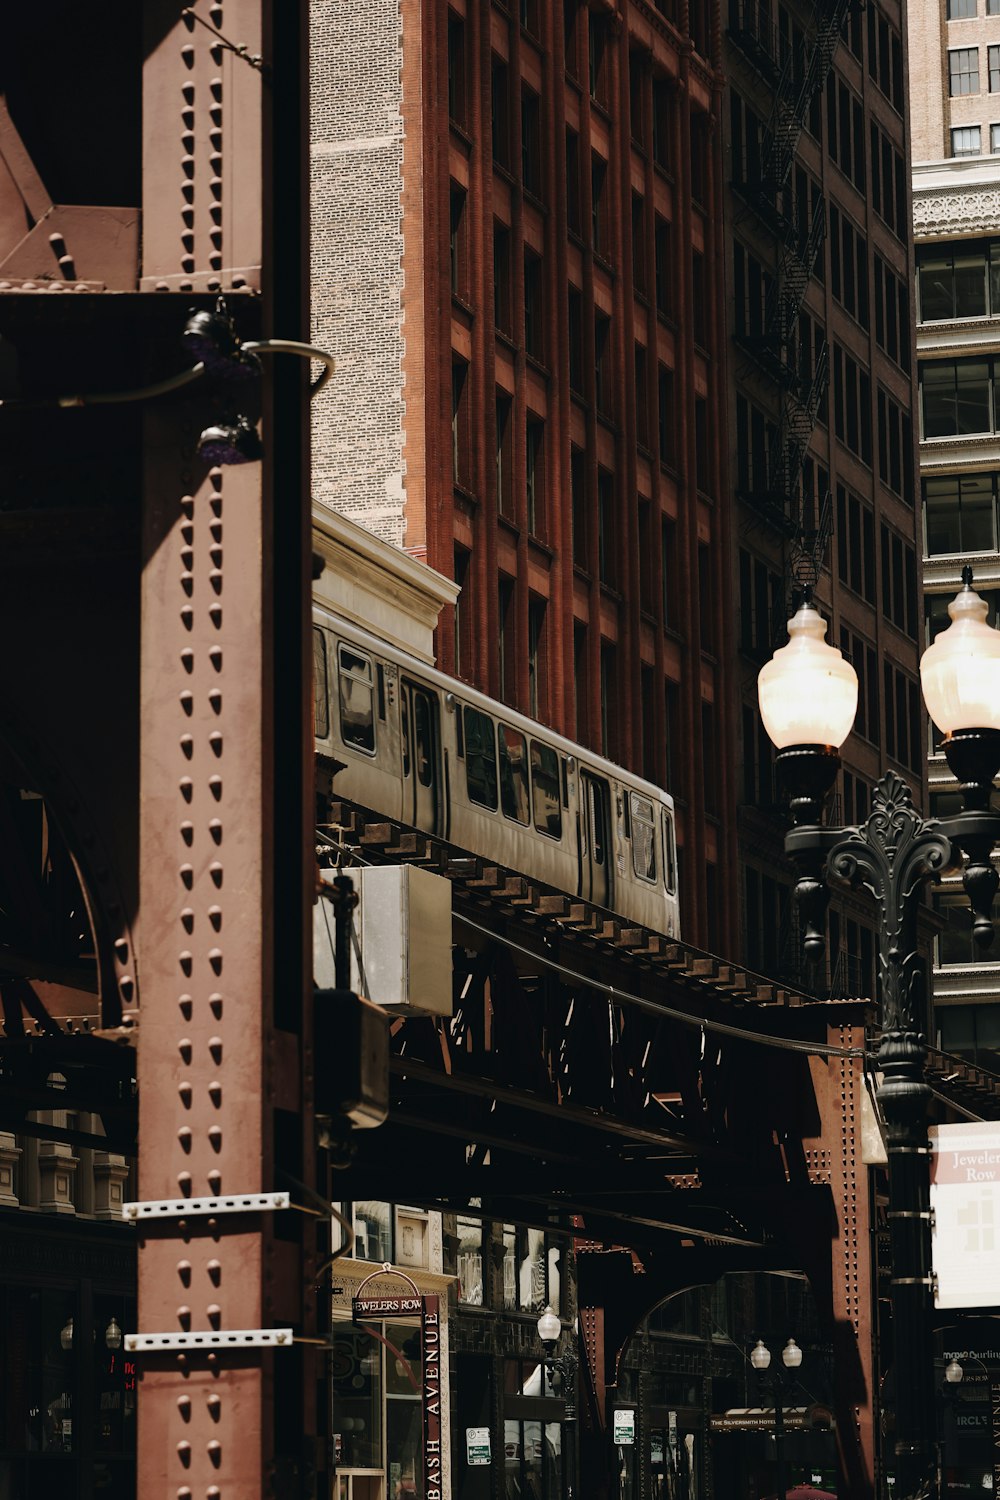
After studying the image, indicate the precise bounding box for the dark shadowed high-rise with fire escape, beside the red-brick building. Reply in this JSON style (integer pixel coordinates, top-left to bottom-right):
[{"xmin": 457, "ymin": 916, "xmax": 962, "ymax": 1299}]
[{"xmin": 726, "ymin": 0, "xmax": 924, "ymax": 995}]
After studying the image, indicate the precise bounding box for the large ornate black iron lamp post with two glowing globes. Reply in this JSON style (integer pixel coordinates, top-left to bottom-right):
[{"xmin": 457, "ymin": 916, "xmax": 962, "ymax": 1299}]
[{"xmin": 757, "ymin": 569, "xmax": 1000, "ymax": 1500}]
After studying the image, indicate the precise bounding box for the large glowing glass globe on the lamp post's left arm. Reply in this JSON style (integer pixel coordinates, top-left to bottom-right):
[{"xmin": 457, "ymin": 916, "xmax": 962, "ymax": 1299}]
[{"xmin": 757, "ymin": 599, "xmax": 858, "ymax": 750}]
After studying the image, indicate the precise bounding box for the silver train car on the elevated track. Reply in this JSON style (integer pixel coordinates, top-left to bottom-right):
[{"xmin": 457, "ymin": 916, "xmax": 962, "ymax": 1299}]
[{"xmin": 313, "ymin": 606, "xmax": 679, "ymax": 938}]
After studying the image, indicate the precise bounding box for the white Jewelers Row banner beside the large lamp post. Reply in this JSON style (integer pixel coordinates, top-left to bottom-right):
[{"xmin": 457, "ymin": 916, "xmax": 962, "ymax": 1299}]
[{"xmin": 928, "ymin": 1121, "xmax": 1000, "ymax": 1308}]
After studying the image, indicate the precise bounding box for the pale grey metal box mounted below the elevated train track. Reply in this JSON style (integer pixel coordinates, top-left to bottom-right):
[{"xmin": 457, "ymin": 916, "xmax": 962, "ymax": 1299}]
[{"xmin": 313, "ymin": 864, "xmax": 451, "ymax": 1016}]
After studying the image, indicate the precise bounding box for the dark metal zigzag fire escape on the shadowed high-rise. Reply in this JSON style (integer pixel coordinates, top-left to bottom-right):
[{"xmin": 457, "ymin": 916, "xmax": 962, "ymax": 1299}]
[{"xmin": 729, "ymin": 0, "xmax": 852, "ymax": 603}]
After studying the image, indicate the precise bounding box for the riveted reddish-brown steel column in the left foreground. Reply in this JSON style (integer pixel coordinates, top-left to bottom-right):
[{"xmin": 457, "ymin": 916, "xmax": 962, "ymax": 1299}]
[{"xmin": 136, "ymin": 0, "xmax": 313, "ymax": 1500}]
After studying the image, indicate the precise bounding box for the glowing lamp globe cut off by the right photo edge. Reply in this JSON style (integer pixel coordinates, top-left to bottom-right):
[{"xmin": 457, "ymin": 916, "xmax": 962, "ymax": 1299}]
[{"xmin": 921, "ymin": 569, "xmax": 1000, "ymax": 740}]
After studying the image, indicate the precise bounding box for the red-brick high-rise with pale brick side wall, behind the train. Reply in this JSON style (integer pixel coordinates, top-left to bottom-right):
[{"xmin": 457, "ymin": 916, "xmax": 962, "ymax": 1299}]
[{"xmin": 313, "ymin": 0, "xmax": 736, "ymax": 951}]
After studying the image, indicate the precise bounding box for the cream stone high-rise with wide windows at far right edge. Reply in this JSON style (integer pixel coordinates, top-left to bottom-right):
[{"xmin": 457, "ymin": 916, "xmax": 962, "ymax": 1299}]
[{"xmin": 910, "ymin": 0, "xmax": 1000, "ymax": 1071}]
